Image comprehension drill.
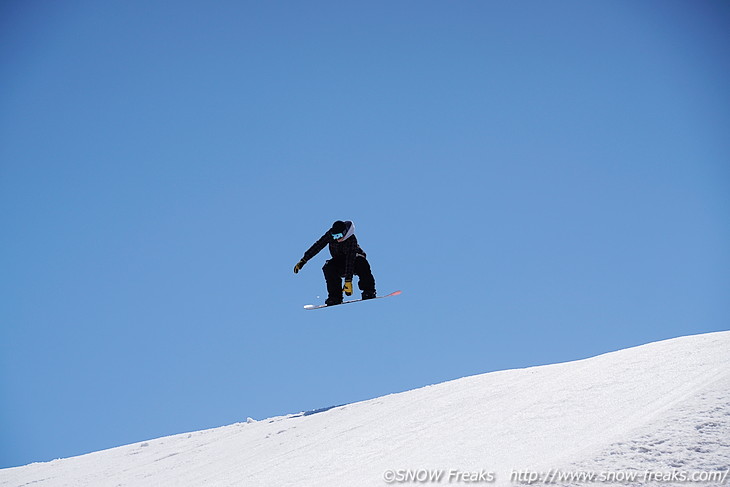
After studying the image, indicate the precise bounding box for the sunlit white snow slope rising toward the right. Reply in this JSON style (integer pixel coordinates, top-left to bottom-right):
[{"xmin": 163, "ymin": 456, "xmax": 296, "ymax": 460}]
[{"xmin": 0, "ymin": 332, "xmax": 730, "ymax": 487}]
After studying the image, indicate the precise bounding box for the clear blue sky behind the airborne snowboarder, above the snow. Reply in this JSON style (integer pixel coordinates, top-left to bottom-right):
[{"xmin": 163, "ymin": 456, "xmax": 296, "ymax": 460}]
[{"xmin": 0, "ymin": 0, "xmax": 730, "ymax": 467}]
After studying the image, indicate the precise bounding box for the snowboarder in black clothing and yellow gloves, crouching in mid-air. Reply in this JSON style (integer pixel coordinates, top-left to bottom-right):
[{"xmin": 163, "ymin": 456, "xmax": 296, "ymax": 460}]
[{"xmin": 294, "ymin": 220, "xmax": 376, "ymax": 306}]
